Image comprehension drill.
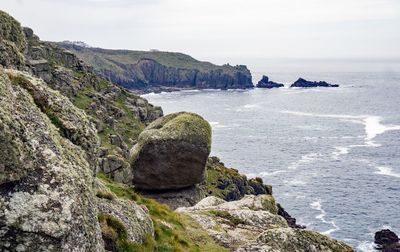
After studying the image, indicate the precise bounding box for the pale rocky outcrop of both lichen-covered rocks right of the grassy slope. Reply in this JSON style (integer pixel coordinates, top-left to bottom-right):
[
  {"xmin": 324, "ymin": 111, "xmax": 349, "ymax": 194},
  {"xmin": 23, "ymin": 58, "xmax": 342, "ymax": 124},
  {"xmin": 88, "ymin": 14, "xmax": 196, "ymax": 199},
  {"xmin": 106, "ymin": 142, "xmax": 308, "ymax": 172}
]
[{"xmin": 176, "ymin": 195, "xmax": 353, "ymax": 252}]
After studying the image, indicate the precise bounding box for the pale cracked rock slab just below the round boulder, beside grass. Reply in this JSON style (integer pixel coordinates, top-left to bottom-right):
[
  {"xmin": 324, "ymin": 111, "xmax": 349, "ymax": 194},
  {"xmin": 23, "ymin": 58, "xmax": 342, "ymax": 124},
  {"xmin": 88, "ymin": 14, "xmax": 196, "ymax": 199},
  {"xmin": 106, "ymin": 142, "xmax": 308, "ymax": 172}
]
[{"xmin": 176, "ymin": 195, "xmax": 287, "ymax": 249}]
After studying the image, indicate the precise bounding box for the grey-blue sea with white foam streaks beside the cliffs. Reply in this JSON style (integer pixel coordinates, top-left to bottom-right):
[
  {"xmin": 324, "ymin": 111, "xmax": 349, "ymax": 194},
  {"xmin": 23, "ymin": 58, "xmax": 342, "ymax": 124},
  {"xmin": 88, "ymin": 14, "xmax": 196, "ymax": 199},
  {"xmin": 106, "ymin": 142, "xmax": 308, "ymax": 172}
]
[{"xmin": 144, "ymin": 64, "xmax": 400, "ymax": 251}]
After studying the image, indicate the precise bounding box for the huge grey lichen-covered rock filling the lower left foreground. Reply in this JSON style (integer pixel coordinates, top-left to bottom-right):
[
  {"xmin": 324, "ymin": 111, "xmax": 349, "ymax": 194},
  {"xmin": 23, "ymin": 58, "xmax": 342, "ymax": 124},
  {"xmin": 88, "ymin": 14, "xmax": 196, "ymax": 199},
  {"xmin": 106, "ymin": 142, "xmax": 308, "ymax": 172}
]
[{"xmin": 0, "ymin": 68, "xmax": 104, "ymax": 251}]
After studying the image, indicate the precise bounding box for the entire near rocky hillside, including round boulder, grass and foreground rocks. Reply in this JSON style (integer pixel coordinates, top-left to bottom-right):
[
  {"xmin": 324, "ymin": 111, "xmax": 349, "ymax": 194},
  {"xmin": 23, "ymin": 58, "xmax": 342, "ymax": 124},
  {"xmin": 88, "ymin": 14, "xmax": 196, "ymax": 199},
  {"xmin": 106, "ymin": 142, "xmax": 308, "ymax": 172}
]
[{"xmin": 0, "ymin": 11, "xmax": 352, "ymax": 252}]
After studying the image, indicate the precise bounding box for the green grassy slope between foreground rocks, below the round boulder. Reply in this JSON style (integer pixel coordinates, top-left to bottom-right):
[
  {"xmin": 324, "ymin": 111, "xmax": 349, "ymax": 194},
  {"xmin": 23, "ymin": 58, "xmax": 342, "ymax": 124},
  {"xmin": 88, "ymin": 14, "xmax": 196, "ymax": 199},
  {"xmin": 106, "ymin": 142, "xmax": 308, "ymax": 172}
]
[{"xmin": 97, "ymin": 173, "xmax": 227, "ymax": 252}]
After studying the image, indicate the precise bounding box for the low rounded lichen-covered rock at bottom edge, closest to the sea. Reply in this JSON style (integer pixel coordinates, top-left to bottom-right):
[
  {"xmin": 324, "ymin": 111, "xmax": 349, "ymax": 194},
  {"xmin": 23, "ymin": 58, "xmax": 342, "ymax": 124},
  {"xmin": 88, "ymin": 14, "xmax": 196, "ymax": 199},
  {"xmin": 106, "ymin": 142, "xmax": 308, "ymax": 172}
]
[{"xmin": 236, "ymin": 228, "xmax": 354, "ymax": 252}]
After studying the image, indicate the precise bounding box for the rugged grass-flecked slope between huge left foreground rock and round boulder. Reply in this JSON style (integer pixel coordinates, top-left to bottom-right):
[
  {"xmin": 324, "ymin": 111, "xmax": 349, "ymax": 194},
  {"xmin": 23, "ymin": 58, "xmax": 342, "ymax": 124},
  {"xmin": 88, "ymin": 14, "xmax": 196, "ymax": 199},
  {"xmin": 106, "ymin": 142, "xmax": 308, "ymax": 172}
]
[{"xmin": 14, "ymin": 22, "xmax": 163, "ymax": 179}]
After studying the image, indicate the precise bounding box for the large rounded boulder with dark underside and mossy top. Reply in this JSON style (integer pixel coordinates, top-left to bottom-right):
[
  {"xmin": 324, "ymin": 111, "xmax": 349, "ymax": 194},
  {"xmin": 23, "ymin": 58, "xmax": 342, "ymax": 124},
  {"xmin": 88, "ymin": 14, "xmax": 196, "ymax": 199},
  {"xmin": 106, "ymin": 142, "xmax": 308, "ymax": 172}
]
[{"xmin": 131, "ymin": 112, "xmax": 211, "ymax": 190}]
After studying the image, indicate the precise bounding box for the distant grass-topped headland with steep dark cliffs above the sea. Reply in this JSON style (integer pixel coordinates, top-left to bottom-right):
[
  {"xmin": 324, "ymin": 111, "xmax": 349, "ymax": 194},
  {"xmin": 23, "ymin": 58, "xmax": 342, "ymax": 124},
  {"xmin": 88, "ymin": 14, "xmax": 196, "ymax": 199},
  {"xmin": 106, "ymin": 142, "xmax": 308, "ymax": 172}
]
[{"xmin": 59, "ymin": 43, "xmax": 253, "ymax": 92}]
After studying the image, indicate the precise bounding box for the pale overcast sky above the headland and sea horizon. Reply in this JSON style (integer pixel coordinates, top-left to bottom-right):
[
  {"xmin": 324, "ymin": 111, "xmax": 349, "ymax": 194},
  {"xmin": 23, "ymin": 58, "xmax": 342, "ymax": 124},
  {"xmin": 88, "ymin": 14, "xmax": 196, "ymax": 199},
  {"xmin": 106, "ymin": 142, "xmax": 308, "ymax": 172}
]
[{"xmin": 0, "ymin": 0, "xmax": 400, "ymax": 64}]
